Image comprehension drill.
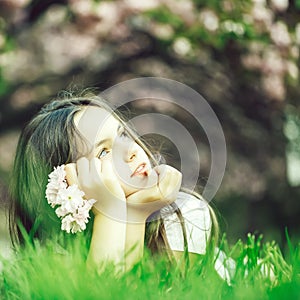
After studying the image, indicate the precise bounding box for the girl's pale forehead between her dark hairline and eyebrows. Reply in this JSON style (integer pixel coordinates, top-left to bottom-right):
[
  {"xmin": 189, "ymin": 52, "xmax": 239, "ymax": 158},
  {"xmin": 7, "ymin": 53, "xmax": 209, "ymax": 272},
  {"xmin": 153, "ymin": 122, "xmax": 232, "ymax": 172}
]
[{"xmin": 74, "ymin": 106, "xmax": 120, "ymax": 142}]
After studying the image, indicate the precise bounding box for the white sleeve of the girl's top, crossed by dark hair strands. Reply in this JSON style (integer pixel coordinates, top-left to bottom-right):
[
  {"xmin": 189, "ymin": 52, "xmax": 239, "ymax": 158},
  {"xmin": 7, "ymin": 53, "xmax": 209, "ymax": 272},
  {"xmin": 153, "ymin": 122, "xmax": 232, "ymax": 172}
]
[{"xmin": 160, "ymin": 192, "xmax": 212, "ymax": 254}]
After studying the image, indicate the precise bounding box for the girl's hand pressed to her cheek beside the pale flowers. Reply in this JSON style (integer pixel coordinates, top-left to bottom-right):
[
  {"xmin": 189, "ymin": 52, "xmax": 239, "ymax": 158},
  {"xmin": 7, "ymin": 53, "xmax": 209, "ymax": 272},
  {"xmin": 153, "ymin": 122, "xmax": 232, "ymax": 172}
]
[{"xmin": 65, "ymin": 157, "xmax": 126, "ymax": 215}]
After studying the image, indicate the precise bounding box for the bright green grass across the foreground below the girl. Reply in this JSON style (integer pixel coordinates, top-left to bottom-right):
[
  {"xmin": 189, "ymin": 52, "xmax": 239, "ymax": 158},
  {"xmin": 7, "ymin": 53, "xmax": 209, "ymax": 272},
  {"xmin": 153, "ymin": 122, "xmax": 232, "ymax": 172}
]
[{"xmin": 0, "ymin": 235, "xmax": 300, "ymax": 299}]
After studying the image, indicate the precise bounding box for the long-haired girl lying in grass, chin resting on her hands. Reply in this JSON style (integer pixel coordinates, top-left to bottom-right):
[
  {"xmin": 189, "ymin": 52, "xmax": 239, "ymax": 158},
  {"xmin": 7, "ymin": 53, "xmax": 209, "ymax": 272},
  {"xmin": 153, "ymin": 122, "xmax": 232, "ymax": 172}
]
[{"xmin": 9, "ymin": 96, "xmax": 218, "ymax": 269}]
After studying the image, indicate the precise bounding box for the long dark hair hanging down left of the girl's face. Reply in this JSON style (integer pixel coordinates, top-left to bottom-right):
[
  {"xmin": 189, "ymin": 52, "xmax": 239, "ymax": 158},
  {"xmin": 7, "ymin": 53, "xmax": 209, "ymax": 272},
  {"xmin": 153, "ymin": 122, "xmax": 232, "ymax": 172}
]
[{"xmin": 9, "ymin": 99, "xmax": 91, "ymax": 243}]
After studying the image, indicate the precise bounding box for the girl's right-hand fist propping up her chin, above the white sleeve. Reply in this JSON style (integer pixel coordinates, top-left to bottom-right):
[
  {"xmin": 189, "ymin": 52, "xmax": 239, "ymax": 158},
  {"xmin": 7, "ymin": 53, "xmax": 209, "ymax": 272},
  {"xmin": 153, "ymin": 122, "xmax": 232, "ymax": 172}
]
[{"xmin": 127, "ymin": 165, "xmax": 182, "ymax": 222}]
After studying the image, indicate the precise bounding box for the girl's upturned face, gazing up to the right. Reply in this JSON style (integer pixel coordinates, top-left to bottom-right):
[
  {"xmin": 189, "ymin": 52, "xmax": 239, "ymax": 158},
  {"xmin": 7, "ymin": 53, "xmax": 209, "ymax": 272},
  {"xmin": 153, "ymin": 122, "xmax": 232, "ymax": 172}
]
[{"xmin": 74, "ymin": 106, "xmax": 157, "ymax": 196}]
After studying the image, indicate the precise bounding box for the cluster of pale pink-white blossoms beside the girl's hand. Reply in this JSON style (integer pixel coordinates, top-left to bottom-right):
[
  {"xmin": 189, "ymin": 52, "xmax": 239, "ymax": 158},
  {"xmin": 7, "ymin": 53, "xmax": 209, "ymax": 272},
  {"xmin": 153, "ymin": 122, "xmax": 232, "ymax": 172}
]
[{"xmin": 46, "ymin": 165, "xmax": 96, "ymax": 233}]
